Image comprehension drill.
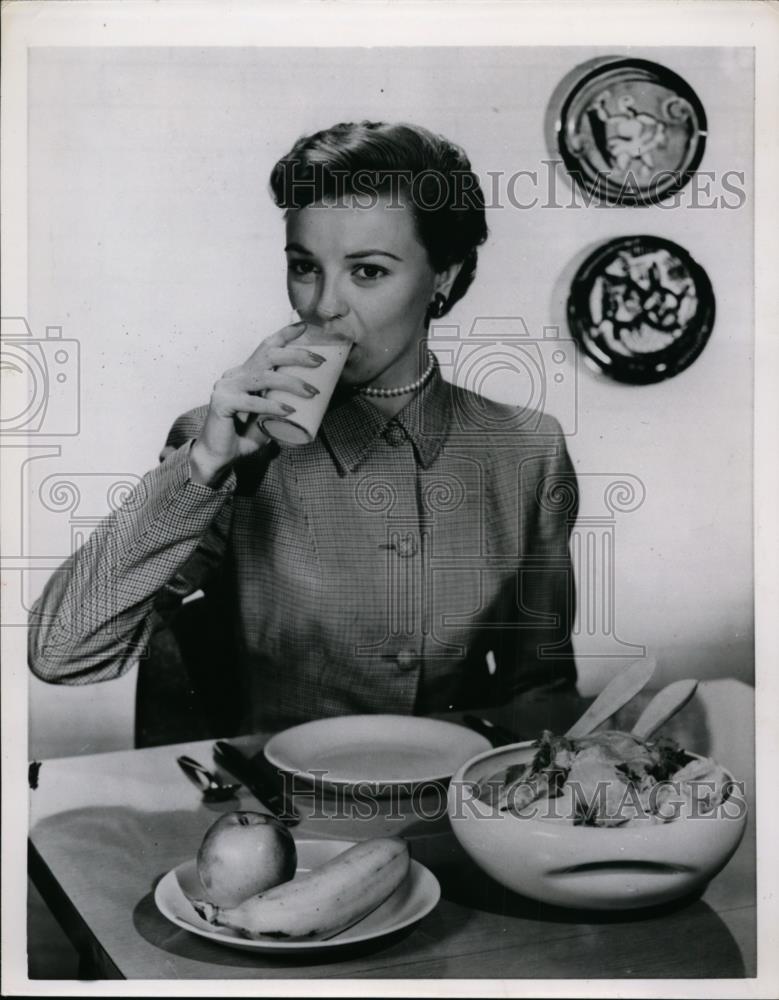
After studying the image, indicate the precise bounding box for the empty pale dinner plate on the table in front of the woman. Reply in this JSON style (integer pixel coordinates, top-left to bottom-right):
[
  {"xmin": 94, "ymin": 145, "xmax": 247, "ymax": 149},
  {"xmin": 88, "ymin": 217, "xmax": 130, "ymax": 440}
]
[{"xmin": 265, "ymin": 715, "xmax": 491, "ymax": 791}]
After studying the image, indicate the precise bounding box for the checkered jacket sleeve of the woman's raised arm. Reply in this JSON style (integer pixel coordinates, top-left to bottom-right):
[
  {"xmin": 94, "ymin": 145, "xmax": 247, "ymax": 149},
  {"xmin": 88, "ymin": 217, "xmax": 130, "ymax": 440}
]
[{"xmin": 28, "ymin": 408, "xmax": 236, "ymax": 684}]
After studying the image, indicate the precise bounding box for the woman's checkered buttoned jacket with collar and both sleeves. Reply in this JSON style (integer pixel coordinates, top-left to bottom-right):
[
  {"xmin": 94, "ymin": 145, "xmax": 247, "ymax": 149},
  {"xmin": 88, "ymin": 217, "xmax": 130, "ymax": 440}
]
[{"xmin": 30, "ymin": 370, "xmax": 577, "ymax": 731}]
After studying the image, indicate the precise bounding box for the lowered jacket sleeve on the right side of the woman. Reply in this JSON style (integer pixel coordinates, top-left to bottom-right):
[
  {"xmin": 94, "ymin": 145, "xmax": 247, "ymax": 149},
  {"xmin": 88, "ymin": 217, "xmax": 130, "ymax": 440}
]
[{"xmin": 496, "ymin": 417, "xmax": 579, "ymax": 695}]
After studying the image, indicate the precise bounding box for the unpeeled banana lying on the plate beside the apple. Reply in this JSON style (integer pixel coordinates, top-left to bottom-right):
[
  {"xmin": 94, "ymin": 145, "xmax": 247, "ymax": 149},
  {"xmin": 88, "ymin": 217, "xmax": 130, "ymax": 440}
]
[{"xmin": 192, "ymin": 837, "xmax": 410, "ymax": 940}]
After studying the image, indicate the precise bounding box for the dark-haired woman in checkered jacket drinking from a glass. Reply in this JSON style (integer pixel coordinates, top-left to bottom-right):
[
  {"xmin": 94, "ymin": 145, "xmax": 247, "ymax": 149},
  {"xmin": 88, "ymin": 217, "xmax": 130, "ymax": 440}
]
[{"xmin": 30, "ymin": 122, "xmax": 575, "ymax": 731}]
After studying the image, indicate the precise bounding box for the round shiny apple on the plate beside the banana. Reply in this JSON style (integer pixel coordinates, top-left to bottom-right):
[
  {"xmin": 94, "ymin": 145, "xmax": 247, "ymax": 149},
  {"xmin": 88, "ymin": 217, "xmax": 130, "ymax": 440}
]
[{"xmin": 197, "ymin": 812, "xmax": 297, "ymax": 906}]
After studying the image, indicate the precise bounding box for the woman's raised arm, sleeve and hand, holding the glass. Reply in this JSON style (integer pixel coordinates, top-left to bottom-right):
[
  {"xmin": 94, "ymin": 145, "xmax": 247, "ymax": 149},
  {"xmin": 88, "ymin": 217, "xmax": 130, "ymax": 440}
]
[{"xmin": 29, "ymin": 323, "xmax": 323, "ymax": 684}]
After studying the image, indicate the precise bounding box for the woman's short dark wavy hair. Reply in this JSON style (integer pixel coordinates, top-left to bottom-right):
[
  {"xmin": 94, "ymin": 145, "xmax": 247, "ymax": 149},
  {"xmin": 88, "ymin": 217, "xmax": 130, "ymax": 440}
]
[{"xmin": 270, "ymin": 121, "xmax": 487, "ymax": 315}]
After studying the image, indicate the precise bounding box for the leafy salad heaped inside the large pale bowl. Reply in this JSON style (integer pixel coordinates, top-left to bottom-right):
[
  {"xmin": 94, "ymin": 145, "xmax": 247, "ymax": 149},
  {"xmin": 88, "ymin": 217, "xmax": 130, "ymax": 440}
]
[{"xmin": 480, "ymin": 730, "xmax": 730, "ymax": 826}]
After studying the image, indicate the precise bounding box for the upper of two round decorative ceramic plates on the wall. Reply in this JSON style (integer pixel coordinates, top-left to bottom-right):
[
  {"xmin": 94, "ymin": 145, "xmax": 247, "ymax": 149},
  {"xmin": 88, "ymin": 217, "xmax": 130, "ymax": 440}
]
[{"xmin": 555, "ymin": 58, "xmax": 706, "ymax": 205}]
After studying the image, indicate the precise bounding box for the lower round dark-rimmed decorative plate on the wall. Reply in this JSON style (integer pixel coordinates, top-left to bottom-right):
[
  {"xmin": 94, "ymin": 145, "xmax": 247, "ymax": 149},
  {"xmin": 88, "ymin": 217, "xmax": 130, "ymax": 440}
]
[{"xmin": 568, "ymin": 236, "xmax": 715, "ymax": 385}]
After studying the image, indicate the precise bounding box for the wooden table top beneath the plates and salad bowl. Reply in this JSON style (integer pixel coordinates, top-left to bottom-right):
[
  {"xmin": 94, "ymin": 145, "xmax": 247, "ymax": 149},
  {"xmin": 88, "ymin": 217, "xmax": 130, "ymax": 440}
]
[{"xmin": 29, "ymin": 681, "xmax": 756, "ymax": 980}]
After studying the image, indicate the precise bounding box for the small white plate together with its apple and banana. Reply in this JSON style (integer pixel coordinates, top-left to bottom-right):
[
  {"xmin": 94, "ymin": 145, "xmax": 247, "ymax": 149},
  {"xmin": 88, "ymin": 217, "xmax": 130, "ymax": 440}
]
[{"xmin": 154, "ymin": 812, "xmax": 441, "ymax": 954}]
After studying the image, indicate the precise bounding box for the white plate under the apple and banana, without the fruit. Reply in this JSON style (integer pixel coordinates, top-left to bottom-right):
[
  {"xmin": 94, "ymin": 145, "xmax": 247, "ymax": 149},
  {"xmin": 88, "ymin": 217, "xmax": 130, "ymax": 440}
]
[{"xmin": 154, "ymin": 840, "xmax": 441, "ymax": 955}]
